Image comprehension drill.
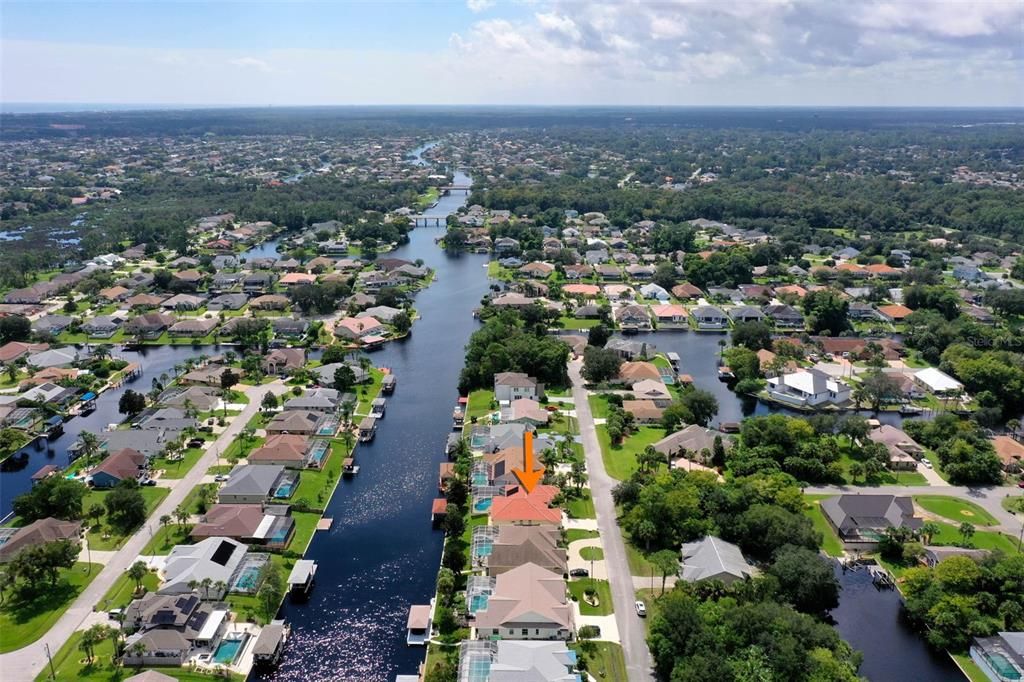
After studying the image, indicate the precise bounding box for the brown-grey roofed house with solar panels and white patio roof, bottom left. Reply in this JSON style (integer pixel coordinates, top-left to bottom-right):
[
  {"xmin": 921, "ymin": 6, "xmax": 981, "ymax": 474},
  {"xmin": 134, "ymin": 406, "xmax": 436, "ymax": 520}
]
[{"xmin": 121, "ymin": 591, "xmax": 228, "ymax": 666}]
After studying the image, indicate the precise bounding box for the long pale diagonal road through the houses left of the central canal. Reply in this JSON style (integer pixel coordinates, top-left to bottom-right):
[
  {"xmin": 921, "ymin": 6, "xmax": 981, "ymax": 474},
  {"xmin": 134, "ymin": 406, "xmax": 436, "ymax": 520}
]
[{"xmin": 0, "ymin": 381, "xmax": 289, "ymax": 682}]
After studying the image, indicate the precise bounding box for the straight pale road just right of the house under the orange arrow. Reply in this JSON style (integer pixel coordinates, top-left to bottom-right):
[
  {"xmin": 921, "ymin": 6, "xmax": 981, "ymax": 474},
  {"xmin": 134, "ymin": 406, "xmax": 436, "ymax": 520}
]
[{"xmin": 569, "ymin": 361, "xmax": 654, "ymax": 682}]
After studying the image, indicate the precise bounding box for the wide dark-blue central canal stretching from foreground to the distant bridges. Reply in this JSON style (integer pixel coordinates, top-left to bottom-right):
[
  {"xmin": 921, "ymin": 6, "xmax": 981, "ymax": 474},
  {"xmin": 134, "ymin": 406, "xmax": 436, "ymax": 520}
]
[{"xmin": 258, "ymin": 165, "xmax": 487, "ymax": 682}]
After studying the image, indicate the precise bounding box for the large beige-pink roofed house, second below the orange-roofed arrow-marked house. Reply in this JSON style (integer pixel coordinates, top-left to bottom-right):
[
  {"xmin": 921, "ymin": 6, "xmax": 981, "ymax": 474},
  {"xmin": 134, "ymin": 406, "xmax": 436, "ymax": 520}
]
[{"xmin": 473, "ymin": 563, "xmax": 573, "ymax": 640}]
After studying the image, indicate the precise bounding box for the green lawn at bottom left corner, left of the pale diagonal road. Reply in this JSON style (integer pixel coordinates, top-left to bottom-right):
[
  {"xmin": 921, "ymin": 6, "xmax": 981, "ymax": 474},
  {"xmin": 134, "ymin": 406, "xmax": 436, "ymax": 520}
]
[{"xmin": 0, "ymin": 562, "xmax": 103, "ymax": 653}]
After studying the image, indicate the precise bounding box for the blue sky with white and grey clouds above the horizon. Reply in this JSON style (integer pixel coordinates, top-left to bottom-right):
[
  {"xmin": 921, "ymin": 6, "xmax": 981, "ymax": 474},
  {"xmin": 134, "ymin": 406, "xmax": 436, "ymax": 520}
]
[{"xmin": 0, "ymin": 0, "xmax": 1024, "ymax": 105}]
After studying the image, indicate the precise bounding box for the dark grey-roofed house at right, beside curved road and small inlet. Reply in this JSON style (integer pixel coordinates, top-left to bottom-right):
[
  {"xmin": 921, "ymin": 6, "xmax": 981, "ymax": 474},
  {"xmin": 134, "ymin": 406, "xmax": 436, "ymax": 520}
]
[{"xmin": 821, "ymin": 495, "xmax": 923, "ymax": 549}]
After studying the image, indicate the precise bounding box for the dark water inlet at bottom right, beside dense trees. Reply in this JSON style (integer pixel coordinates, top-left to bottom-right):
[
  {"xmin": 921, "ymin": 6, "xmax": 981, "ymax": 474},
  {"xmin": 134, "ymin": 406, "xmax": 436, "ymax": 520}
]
[{"xmin": 831, "ymin": 562, "xmax": 964, "ymax": 682}]
